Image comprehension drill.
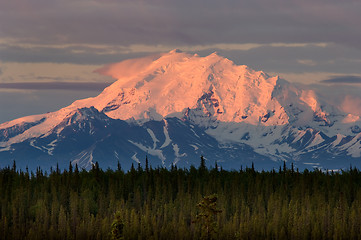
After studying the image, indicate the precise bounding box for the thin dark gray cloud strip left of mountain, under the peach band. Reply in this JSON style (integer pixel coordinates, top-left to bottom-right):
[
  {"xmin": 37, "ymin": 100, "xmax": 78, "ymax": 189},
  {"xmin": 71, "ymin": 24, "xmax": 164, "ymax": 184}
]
[{"xmin": 0, "ymin": 82, "xmax": 111, "ymax": 92}]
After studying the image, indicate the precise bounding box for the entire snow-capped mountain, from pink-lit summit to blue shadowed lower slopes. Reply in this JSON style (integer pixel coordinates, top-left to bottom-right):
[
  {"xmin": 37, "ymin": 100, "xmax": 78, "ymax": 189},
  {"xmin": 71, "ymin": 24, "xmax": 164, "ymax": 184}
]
[{"xmin": 0, "ymin": 50, "xmax": 361, "ymax": 169}]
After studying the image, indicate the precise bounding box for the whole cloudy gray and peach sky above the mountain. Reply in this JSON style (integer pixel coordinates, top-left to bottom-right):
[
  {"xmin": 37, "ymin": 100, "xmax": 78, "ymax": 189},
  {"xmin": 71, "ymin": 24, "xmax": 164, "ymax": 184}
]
[{"xmin": 0, "ymin": 0, "xmax": 361, "ymax": 123}]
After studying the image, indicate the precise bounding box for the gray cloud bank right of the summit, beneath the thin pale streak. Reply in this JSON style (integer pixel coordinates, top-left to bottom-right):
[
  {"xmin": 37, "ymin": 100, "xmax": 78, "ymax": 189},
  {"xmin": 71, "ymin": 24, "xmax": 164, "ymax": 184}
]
[{"xmin": 191, "ymin": 44, "xmax": 361, "ymax": 75}]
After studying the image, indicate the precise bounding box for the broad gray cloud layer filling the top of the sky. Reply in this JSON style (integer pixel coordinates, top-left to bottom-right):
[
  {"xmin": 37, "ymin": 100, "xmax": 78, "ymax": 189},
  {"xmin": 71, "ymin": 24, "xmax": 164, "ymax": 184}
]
[{"xmin": 0, "ymin": 0, "xmax": 361, "ymax": 48}]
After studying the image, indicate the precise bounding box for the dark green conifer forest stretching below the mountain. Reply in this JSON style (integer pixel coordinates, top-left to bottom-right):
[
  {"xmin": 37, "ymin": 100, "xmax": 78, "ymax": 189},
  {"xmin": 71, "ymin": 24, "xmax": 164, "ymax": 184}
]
[{"xmin": 0, "ymin": 158, "xmax": 361, "ymax": 239}]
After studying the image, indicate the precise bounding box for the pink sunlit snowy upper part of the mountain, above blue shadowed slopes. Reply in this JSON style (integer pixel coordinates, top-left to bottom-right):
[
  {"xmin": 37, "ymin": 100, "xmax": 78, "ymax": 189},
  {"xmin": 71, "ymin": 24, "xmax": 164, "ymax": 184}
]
[{"xmin": 3, "ymin": 49, "xmax": 353, "ymax": 129}]
